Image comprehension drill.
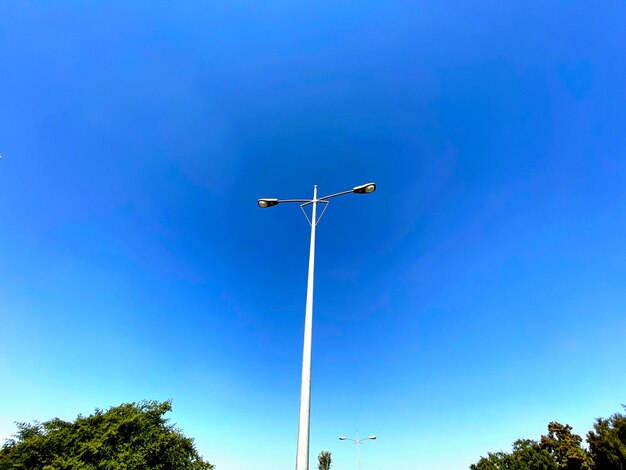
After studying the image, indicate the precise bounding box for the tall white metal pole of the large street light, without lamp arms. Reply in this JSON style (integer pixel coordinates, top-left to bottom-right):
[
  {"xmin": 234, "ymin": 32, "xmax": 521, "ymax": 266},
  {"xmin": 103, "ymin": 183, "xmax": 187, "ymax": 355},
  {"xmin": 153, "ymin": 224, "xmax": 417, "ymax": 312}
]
[{"xmin": 296, "ymin": 185, "xmax": 317, "ymax": 470}]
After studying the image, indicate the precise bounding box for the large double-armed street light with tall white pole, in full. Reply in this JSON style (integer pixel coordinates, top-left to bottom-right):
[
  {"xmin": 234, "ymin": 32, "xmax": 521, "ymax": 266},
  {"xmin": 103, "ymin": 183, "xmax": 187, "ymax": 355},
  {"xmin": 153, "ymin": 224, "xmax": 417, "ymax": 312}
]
[{"xmin": 257, "ymin": 183, "xmax": 376, "ymax": 470}]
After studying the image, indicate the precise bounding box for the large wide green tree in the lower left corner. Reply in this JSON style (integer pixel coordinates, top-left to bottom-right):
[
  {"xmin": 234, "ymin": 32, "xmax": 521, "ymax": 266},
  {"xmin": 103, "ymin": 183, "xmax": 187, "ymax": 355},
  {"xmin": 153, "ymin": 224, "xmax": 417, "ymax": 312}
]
[{"xmin": 0, "ymin": 401, "xmax": 214, "ymax": 470}]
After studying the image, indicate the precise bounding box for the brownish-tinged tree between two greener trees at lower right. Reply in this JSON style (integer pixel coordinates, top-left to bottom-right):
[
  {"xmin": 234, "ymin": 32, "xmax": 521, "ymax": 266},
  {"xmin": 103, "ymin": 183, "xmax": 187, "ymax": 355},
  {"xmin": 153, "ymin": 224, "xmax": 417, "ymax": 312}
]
[{"xmin": 539, "ymin": 421, "xmax": 593, "ymax": 470}]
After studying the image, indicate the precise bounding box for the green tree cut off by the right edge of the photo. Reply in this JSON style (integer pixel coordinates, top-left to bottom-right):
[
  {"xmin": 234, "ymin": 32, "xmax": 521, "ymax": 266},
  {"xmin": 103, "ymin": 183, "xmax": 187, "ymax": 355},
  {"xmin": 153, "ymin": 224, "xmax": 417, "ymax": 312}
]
[{"xmin": 587, "ymin": 406, "xmax": 626, "ymax": 470}]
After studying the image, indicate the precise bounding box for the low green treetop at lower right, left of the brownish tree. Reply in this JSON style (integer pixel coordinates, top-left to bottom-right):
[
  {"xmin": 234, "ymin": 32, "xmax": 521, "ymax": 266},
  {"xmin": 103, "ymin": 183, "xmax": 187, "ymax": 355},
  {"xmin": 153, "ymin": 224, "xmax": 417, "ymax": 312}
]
[{"xmin": 470, "ymin": 439, "xmax": 558, "ymax": 470}]
